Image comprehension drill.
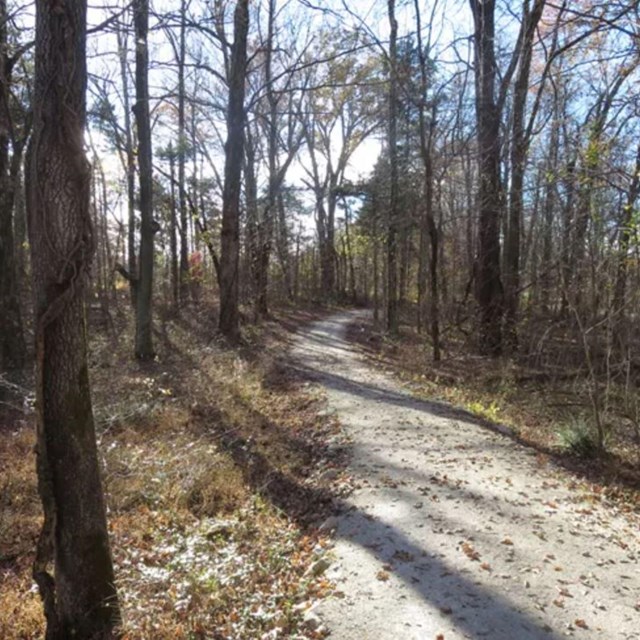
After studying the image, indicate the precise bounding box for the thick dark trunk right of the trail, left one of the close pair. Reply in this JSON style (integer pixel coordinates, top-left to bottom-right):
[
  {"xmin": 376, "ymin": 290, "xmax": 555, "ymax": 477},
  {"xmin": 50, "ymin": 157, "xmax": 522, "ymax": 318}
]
[{"xmin": 470, "ymin": 0, "xmax": 503, "ymax": 356}]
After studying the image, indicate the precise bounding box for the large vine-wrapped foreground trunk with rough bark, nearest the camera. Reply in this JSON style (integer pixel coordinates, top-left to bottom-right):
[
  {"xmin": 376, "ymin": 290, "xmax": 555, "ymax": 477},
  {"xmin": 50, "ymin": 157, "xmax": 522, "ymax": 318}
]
[{"xmin": 26, "ymin": 0, "xmax": 119, "ymax": 640}]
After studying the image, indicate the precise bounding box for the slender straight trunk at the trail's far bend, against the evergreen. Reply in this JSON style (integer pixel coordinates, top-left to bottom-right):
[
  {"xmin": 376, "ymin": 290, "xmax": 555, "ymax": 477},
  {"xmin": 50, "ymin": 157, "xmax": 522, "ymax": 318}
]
[{"xmin": 386, "ymin": 0, "xmax": 398, "ymax": 333}]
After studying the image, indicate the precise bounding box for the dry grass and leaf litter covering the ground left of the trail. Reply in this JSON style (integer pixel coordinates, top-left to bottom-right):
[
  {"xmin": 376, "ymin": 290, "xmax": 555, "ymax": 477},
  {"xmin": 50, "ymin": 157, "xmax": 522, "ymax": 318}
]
[{"xmin": 0, "ymin": 310, "xmax": 338, "ymax": 640}]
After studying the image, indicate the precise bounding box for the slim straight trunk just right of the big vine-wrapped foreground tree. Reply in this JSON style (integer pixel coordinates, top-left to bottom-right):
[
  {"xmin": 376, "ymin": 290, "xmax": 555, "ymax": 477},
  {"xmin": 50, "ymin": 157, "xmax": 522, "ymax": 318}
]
[{"xmin": 133, "ymin": 0, "xmax": 157, "ymax": 360}]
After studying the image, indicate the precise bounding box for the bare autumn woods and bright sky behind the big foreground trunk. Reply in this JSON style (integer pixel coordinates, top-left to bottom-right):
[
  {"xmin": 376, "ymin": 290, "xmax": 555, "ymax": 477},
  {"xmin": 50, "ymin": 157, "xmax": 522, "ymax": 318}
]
[{"xmin": 0, "ymin": 0, "xmax": 640, "ymax": 636}]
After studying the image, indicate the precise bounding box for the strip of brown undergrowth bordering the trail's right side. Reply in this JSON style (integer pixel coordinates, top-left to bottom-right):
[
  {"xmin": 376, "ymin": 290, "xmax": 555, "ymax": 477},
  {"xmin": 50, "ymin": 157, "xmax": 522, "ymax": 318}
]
[{"xmin": 351, "ymin": 323, "xmax": 640, "ymax": 508}]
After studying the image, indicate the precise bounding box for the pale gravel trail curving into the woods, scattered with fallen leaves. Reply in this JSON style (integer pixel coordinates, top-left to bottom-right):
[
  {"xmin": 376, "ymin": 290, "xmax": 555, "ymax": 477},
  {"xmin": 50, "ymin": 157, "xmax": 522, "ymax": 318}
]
[{"xmin": 293, "ymin": 313, "xmax": 640, "ymax": 640}]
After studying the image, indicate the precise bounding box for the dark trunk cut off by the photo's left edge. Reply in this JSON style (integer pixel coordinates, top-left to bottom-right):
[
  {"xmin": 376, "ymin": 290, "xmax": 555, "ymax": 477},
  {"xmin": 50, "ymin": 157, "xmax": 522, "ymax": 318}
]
[{"xmin": 0, "ymin": 0, "xmax": 26, "ymax": 370}]
